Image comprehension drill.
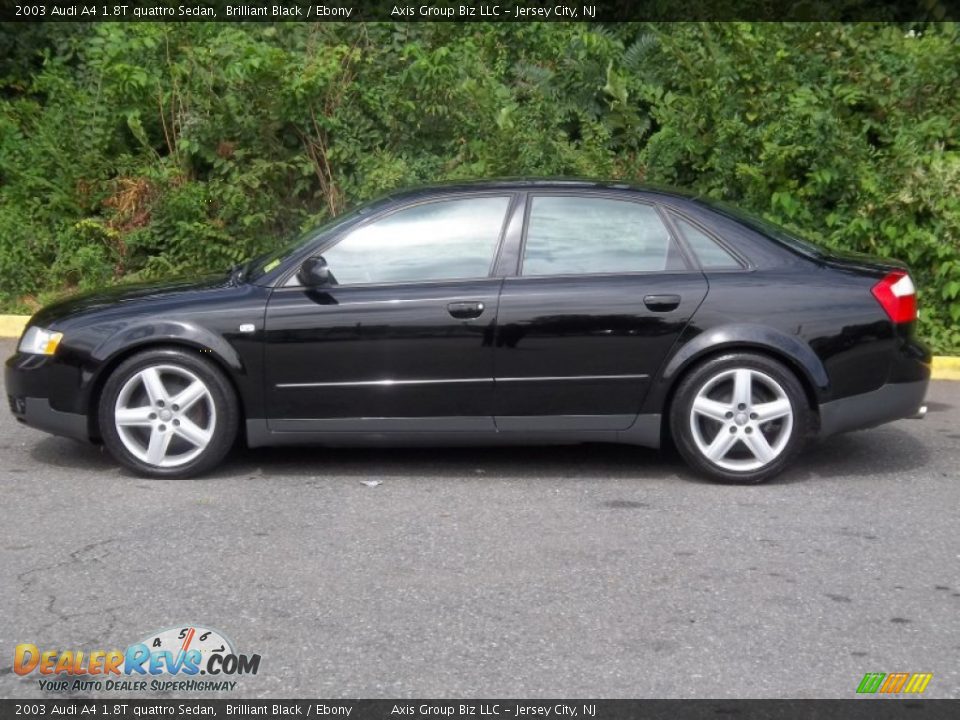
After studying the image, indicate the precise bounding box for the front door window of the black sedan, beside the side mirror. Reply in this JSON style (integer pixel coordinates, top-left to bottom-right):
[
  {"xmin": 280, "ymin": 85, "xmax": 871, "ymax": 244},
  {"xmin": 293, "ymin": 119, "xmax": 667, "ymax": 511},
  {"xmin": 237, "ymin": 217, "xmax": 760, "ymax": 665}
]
[{"xmin": 323, "ymin": 196, "xmax": 510, "ymax": 285}]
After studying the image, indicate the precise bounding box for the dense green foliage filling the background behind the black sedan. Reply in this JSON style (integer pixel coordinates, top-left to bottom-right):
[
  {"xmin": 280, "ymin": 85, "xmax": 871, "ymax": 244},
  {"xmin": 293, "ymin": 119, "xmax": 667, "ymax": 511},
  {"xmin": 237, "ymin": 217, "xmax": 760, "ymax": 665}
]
[{"xmin": 0, "ymin": 23, "xmax": 960, "ymax": 352}]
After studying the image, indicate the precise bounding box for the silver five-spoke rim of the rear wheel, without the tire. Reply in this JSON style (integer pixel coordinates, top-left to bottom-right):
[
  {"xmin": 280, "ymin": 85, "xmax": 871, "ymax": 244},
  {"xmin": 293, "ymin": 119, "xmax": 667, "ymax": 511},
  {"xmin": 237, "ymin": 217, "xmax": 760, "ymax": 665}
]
[{"xmin": 689, "ymin": 367, "xmax": 794, "ymax": 472}]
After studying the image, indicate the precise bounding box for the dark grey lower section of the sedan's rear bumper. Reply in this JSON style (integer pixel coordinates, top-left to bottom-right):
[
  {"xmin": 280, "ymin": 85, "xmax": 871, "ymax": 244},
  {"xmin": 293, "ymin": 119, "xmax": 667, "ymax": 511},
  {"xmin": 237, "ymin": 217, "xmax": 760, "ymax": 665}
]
[{"xmin": 820, "ymin": 379, "xmax": 929, "ymax": 436}]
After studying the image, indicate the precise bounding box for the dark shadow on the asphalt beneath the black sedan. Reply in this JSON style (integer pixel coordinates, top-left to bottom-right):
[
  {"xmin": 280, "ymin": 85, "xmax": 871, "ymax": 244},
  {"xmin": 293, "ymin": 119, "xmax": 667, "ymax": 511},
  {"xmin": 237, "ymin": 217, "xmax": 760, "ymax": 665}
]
[{"xmin": 30, "ymin": 427, "xmax": 929, "ymax": 485}]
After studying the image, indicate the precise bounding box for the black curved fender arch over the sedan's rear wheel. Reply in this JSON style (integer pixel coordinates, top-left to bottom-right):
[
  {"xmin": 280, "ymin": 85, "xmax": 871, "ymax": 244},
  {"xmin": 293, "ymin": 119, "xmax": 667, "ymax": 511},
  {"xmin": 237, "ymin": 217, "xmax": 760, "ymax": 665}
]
[{"xmin": 660, "ymin": 323, "xmax": 830, "ymax": 400}]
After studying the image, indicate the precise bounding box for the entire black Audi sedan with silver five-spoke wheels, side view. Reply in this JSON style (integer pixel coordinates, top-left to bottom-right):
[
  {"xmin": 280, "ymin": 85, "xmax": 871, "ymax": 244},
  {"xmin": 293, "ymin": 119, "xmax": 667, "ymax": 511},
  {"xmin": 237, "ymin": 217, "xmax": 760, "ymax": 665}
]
[{"xmin": 6, "ymin": 180, "xmax": 930, "ymax": 483}]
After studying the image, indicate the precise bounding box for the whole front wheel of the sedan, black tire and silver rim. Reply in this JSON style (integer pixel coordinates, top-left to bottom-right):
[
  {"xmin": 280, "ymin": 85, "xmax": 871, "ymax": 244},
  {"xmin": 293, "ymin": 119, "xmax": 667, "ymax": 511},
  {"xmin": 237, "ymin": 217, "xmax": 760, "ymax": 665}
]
[{"xmin": 99, "ymin": 348, "xmax": 239, "ymax": 478}]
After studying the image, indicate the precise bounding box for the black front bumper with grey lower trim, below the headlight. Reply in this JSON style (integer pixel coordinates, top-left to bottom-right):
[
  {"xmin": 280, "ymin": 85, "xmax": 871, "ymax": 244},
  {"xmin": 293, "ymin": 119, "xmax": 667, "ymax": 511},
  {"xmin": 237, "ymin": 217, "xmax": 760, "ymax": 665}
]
[{"xmin": 4, "ymin": 353, "xmax": 90, "ymax": 440}]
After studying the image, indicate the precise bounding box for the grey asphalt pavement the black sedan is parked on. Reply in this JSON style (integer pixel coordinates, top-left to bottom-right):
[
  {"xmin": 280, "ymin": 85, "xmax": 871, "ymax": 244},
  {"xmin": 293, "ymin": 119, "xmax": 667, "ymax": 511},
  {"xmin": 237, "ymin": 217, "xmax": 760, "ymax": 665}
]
[{"xmin": 0, "ymin": 341, "xmax": 960, "ymax": 698}]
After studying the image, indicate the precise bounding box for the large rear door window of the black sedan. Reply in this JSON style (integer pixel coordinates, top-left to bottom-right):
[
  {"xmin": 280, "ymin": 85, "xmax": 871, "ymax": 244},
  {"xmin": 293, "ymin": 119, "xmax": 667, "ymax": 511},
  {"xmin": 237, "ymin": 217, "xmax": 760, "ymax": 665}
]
[{"xmin": 522, "ymin": 196, "xmax": 683, "ymax": 275}]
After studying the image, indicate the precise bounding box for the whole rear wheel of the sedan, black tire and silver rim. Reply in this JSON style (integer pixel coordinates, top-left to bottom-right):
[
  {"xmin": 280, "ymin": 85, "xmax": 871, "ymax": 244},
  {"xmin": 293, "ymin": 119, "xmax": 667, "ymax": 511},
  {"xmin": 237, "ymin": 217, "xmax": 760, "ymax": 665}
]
[{"xmin": 670, "ymin": 353, "xmax": 811, "ymax": 483}]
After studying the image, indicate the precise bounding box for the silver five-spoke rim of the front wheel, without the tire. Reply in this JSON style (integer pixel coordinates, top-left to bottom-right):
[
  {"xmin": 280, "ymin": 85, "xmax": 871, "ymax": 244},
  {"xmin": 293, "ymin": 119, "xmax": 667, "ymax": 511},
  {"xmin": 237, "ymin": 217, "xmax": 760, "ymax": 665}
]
[{"xmin": 113, "ymin": 365, "xmax": 217, "ymax": 468}]
